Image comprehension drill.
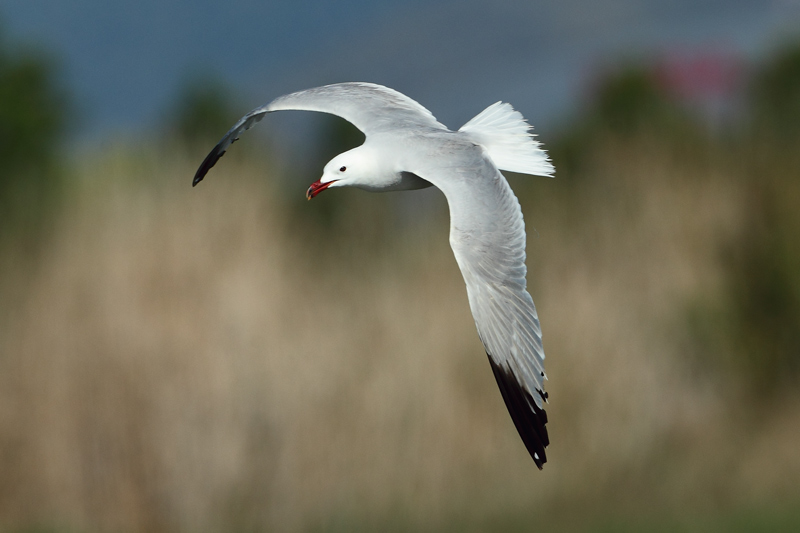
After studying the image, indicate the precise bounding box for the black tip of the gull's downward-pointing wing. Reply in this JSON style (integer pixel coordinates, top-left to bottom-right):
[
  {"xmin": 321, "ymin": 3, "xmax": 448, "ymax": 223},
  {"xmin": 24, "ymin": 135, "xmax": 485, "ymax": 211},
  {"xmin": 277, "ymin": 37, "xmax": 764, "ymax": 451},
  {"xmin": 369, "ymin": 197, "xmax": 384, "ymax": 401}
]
[{"xmin": 487, "ymin": 354, "xmax": 550, "ymax": 470}]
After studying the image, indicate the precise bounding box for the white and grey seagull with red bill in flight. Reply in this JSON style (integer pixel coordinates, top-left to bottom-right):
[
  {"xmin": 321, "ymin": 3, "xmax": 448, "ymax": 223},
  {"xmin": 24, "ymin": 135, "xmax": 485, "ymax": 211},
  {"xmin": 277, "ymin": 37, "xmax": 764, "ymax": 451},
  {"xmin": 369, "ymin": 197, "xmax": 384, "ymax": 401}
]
[{"xmin": 192, "ymin": 83, "xmax": 555, "ymax": 470}]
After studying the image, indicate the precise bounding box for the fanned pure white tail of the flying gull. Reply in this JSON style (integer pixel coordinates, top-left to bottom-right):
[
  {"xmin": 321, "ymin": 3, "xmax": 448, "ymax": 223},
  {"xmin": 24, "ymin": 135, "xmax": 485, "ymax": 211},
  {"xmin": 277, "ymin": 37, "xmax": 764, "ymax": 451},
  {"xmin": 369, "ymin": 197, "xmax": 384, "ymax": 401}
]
[{"xmin": 458, "ymin": 102, "xmax": 555, "ymax": 176}]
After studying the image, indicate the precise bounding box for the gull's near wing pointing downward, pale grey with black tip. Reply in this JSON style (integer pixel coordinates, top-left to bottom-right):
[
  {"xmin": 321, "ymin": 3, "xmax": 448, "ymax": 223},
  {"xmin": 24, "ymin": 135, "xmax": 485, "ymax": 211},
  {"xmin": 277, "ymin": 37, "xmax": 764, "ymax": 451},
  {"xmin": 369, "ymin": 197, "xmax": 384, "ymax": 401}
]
[{"xmin": 413, "ymin": 145, "xmax": 550, "ymax": 469}]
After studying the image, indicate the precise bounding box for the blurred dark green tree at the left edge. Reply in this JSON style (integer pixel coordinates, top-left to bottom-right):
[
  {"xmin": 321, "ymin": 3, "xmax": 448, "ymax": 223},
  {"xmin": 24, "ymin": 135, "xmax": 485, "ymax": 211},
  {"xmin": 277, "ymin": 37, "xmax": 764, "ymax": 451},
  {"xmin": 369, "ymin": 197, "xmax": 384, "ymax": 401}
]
[{"xmin": 0, "ymin": 23, "xmax": 68, "ymax": 243}]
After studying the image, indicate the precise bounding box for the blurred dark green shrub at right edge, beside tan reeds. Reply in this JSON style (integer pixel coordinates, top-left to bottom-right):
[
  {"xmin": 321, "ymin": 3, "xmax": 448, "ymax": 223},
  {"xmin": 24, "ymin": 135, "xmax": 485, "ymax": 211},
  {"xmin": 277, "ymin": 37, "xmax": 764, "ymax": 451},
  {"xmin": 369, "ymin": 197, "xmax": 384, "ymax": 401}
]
[{"xmin": 726, "ymin": 169, "xmax": 800, "ymax": 390}]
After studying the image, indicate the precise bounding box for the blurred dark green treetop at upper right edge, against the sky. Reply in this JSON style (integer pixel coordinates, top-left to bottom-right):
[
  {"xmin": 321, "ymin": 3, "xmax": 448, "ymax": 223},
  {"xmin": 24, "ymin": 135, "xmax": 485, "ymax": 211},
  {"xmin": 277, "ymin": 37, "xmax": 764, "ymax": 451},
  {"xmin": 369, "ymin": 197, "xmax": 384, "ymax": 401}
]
[{"xmin": 751, "ymin": 43, "xmax": 800, "ymax": 140}]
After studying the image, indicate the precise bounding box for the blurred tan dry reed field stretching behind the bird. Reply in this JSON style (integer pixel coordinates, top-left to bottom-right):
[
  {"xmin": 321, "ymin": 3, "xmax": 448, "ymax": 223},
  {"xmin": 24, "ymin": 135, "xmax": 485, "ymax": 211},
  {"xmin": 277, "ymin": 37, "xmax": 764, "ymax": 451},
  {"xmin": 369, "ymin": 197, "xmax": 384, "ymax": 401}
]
[{"xmin": 0, "ymin": 142, "xmax": 800, "ymax": 532}]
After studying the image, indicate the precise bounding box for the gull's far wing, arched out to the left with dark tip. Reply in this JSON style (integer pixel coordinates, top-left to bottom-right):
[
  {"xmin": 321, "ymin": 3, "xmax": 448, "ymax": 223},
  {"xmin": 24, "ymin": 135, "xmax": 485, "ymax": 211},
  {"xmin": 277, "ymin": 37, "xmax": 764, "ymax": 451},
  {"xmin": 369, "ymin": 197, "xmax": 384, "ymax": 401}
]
[{"xmin": 192, "ymin": 83, "xmax": 447, "ymax": 185}]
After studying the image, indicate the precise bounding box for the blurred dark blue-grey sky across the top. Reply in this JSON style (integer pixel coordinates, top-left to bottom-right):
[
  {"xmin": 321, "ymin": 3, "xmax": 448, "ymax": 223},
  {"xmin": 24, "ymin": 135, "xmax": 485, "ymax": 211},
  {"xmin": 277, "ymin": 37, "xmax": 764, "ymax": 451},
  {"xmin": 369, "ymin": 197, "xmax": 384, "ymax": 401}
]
[{"xmin": 0, "ymin": 0, "xmax": 800, "ymax": 137}]
